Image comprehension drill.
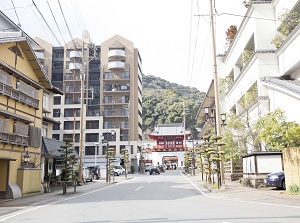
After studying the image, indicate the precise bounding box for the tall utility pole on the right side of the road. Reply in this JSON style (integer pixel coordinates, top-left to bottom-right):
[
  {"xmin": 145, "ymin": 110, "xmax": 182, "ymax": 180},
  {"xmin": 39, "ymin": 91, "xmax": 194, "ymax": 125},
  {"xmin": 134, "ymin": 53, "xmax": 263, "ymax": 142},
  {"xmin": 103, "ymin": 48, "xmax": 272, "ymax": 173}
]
[{"xmin": 210, "ymin": 0, "xmax": 225, "ymax": 184}]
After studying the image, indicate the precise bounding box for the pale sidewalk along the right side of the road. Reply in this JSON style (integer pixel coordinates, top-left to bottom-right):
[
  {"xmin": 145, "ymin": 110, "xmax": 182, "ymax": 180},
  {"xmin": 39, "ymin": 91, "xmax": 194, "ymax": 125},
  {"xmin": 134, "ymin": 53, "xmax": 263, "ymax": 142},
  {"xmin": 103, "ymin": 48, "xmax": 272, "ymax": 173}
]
[{"xmin": 186, "ymin": 175, "xmax": 300, "ymax": 207}]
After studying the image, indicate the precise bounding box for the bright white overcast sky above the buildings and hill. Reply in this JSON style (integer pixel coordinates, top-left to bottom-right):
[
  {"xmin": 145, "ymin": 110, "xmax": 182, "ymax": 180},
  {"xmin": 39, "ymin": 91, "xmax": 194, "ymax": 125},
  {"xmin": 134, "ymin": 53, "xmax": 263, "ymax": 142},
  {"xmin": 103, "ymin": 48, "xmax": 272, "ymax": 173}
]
[{"xmin": 0, "ymin": 0, "xmax": 246, "ymax": 92}]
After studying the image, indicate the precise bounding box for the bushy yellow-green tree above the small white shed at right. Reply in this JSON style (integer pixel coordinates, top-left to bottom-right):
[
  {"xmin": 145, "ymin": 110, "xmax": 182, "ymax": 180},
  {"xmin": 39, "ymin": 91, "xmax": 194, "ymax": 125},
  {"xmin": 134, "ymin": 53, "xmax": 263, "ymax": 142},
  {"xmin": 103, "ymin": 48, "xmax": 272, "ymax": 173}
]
[{"xmin": 256, "ymin": 108, "xmax": 300, "ymax": 151}]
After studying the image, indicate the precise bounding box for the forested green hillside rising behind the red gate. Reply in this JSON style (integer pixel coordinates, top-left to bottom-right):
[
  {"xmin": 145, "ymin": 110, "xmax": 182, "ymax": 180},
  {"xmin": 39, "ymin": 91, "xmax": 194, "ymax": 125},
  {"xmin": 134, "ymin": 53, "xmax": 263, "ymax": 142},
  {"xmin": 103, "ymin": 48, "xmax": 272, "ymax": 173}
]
[{"xmin": 143, "ymin": 75, "xmax": 205, "ymax": 138}]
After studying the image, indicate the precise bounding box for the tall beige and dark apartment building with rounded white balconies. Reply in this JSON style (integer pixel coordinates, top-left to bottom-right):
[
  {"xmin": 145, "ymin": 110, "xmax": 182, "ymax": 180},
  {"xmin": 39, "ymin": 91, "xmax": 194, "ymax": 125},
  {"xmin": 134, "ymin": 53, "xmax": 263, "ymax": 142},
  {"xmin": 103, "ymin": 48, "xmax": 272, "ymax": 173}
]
[{"xmin": 35, "ymin": 31, "xmax": 142, "ymax": 171}]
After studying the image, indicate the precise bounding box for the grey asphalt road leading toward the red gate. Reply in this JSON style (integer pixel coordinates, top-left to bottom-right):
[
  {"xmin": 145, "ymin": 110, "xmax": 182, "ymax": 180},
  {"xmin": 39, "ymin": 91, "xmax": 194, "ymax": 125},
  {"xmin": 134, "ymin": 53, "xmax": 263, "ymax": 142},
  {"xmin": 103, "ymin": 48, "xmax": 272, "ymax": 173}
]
[{"xmin": 0, "ymin": 171, "xmax": 300, "ymax": 223}]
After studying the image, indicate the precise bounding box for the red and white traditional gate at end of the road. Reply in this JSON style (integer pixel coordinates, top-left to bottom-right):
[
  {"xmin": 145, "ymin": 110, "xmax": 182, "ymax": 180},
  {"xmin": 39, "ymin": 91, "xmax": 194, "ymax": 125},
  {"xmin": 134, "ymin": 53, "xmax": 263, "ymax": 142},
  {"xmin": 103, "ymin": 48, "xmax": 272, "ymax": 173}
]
[{"xmin": 149, "ymin": 123, "xmax": 191, "ymax": 167}]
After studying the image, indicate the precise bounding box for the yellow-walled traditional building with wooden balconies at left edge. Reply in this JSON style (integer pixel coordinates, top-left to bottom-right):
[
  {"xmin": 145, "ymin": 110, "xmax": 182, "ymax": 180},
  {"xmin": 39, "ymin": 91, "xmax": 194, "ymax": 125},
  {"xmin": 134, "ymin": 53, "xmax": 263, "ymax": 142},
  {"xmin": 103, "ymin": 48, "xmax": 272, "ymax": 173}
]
[{"xmin": 0, "ymin": 31, "xmax": 56, "ymax": 198}]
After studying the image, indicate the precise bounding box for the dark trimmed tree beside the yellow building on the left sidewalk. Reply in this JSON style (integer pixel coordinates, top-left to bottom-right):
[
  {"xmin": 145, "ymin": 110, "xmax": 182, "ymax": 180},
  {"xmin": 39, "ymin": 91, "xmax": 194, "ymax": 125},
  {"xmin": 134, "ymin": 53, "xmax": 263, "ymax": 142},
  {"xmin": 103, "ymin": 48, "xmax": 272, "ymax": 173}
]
[{"xmin": 58, "ymin": 138, "xmax": 77, "ymax": 194}]
